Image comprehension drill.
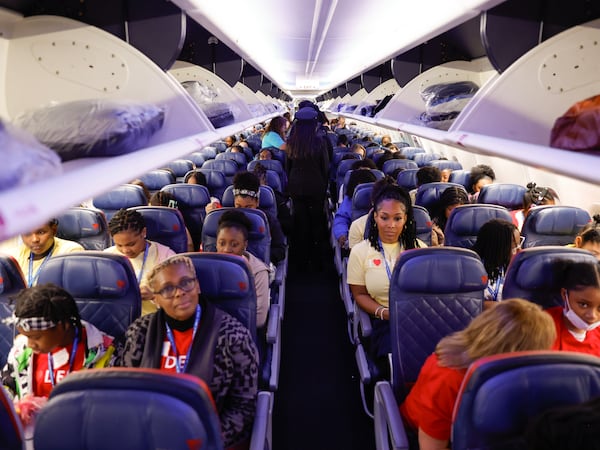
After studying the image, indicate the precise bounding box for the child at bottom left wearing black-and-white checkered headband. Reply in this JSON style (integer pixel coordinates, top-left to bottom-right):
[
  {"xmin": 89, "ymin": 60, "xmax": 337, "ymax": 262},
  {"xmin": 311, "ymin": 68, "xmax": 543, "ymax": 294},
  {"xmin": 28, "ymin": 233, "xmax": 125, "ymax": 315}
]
[{"xmin": 2, "ymin": 283, "xmax": 114, "ymax": 424}]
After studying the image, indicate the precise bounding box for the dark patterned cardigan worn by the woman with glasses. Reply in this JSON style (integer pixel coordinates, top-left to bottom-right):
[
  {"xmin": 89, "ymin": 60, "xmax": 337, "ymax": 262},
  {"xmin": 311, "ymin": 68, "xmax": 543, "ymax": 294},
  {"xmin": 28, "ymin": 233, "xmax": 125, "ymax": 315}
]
[{"xmin": 114, "ymin": 301, "xmax": 258, "ymax": 447}]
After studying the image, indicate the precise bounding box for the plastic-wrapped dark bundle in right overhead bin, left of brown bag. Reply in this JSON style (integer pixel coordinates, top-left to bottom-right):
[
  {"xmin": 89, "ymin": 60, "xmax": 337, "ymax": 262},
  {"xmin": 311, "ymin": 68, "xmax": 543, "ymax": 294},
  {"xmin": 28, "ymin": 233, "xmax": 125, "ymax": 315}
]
[{"xmin": 421, "ymin": 81, "xmax": 479, "ymax": 116}]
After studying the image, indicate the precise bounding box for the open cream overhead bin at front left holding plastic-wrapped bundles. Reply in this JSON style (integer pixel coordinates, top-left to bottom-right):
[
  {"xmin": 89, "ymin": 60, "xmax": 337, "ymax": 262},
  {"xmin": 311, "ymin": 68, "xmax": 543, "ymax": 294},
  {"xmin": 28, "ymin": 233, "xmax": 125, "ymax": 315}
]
[{"xmin": 0, "ymin": 10, "xmax": 272, "ymax": 239}]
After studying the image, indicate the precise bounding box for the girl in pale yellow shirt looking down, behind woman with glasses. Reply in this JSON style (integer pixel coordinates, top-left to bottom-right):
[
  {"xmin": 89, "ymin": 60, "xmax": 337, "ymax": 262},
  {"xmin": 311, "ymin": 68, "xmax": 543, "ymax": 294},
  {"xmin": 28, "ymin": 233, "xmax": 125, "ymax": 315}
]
[{"xmin": 104, "ymin": 209, "xmax": 175, "ymax": 314}]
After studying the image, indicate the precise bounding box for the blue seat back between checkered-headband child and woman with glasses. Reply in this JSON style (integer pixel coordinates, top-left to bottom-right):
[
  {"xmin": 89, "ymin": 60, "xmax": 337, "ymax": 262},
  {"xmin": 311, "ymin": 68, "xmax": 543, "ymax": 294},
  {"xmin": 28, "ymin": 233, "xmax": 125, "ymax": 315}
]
[{"xmin": 38, "ymin": 250, "xmax": 142, "ymax": 338}]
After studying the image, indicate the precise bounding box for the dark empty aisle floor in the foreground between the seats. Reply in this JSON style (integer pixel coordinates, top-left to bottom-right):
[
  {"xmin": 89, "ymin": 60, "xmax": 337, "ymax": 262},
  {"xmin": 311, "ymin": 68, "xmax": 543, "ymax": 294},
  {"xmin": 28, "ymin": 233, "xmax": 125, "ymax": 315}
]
[{"xmin": 273, "ymin": 248, "xmax": 375, "ymax": 450}]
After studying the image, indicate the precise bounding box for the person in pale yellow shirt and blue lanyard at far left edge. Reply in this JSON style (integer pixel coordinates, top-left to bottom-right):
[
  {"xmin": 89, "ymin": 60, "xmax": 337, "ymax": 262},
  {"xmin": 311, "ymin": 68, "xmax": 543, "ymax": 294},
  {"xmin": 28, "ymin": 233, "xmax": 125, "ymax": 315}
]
[{"xmin": 7, "ymin": 219, "xmax": 85, "ymax": 287}]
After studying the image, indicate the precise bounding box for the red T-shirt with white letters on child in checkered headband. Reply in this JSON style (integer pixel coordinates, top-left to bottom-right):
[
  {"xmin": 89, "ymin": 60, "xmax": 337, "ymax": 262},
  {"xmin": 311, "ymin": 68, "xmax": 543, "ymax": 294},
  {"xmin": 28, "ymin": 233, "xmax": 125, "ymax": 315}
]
[{"xmin": 32, "ymin": 333, "xmax": 86, "ymax": 397}]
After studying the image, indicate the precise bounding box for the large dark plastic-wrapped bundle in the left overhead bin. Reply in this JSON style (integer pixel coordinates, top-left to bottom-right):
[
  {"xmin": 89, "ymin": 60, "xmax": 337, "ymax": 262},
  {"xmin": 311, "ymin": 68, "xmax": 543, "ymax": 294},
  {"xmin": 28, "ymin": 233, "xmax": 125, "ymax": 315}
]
[{"xmin": 15, "ymin": 100, "xmax": 164, "ymax": 161}]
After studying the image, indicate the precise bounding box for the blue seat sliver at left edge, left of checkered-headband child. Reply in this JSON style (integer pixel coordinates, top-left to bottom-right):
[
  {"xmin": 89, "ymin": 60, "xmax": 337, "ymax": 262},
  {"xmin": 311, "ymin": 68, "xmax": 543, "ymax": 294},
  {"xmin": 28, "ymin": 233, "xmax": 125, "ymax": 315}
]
[{"xmin": 0, "ymin": 253, "xmax": 26, "ymax": 367}]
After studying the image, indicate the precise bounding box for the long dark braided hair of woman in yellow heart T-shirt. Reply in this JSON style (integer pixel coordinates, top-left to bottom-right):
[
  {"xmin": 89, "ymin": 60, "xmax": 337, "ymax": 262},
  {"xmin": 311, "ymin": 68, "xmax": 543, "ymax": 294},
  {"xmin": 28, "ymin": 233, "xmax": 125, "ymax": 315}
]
[{"xmin": 367, "ymin": 177, "xmax": 419, "ymax": 251}]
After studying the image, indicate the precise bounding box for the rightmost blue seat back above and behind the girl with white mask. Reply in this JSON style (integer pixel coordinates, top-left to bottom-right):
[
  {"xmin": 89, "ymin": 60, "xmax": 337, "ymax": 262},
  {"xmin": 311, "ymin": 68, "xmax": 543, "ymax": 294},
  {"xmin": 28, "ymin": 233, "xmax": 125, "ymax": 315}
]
[{"xmin": 521, "ymin": 205, "xmax": 592, "ymax": 248}]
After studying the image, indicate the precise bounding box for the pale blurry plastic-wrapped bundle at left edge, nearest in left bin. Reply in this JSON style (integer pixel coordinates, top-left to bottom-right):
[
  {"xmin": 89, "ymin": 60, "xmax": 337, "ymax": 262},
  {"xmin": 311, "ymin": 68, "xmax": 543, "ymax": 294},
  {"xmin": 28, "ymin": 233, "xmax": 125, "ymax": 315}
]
[{"xmin": 0, "ymin": 120, "xmax": 62, "ymax": 190}]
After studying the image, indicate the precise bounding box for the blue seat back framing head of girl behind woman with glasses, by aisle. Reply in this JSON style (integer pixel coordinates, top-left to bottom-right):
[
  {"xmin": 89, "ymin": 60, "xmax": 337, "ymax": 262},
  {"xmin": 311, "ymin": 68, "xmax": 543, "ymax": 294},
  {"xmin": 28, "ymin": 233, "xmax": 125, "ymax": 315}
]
[{"xmin": 202, "ymin": 207, "xmax": 271, "ymax": 264}]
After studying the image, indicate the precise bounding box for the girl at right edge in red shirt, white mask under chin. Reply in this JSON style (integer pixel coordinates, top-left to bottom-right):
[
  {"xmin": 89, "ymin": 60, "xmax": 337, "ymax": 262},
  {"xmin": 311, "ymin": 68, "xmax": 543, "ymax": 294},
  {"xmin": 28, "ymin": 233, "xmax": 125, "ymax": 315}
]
[{"xmin": 546, "ymin": 260, "xmax": 600, "ymax": 356}]
